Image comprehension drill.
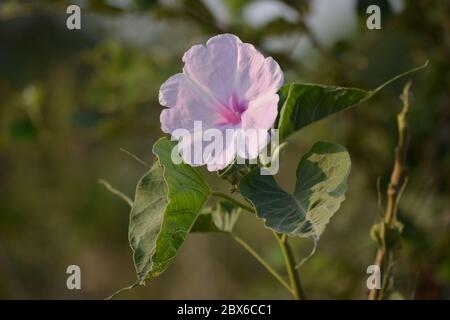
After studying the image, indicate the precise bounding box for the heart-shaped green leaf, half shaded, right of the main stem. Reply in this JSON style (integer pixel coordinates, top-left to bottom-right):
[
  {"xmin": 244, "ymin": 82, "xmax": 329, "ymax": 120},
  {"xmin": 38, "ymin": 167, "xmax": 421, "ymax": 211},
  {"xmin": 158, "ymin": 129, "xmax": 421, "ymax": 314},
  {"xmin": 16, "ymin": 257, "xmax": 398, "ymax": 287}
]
[{"xmin": 239, "ymin": 142, "xmax": 351, "ymax": 238}]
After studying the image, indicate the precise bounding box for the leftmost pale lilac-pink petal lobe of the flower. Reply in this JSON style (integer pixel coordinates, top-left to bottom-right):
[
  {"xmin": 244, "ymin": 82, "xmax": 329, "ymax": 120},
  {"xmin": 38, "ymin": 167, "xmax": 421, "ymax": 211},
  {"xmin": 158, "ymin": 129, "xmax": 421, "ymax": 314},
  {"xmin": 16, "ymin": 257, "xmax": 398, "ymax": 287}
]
[{"xmin": 159, "ymin": 73, "xmax": 223, "ymax": 133}]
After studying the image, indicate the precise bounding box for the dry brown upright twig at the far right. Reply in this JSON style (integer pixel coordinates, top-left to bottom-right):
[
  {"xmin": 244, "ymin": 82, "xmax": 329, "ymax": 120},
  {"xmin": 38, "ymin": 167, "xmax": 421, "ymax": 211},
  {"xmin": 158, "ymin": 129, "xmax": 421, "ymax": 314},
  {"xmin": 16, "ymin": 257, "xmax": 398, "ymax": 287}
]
[{"xmin": 369, "ymin": 82, "xmax": 411, "ymax": 300}]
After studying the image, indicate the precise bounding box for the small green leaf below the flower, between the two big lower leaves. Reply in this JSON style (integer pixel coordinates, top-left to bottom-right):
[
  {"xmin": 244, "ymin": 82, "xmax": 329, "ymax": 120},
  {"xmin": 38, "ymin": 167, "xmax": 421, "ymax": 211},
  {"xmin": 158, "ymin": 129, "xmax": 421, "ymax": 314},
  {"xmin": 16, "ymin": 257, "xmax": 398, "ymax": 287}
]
[{"xmin": 191, "ymin": 200, "xmax": 241, "ymax": 232}]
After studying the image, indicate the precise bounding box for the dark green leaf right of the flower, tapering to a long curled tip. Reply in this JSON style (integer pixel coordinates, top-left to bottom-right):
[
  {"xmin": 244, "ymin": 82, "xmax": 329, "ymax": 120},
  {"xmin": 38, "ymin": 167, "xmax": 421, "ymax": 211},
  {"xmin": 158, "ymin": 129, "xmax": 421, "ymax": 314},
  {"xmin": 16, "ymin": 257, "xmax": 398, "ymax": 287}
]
[{"xmin": 277, "ymin": 61, "xmax": 428, "ymax": 140}]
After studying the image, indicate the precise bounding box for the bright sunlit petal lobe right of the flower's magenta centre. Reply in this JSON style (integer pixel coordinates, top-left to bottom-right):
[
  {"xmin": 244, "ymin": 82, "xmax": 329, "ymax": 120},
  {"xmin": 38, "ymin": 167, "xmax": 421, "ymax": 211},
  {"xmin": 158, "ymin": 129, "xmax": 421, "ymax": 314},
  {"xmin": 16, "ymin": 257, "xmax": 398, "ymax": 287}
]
[{"xmin": 241, "ymin": 93, "xmax": 279, "ymax": 130}]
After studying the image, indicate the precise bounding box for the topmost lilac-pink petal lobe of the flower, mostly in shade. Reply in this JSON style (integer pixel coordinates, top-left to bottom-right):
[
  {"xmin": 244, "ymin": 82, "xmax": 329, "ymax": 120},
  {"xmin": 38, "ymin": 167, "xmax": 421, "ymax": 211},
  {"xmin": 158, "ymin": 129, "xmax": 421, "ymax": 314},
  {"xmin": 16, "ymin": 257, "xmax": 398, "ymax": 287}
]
[{"xmin": 183, "ymin": 34, "xmax": 242, "ymax": 106}]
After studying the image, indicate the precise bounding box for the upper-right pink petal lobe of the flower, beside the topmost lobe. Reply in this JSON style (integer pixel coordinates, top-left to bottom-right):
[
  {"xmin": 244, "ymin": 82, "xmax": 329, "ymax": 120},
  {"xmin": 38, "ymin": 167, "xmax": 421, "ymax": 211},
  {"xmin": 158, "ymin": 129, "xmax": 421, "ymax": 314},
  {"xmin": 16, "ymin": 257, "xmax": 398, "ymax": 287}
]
[{"xmin": 236, "ymin": 43, "xmax": 284, "ymax": 101}]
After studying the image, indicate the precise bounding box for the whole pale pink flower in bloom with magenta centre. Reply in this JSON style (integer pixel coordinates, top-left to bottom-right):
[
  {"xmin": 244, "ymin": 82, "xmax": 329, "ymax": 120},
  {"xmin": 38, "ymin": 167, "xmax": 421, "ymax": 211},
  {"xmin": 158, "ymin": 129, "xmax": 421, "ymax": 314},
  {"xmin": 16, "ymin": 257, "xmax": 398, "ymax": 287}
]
[{"xmin": 159, "ymin": 34, "xmax": 283, "ymax": 171}]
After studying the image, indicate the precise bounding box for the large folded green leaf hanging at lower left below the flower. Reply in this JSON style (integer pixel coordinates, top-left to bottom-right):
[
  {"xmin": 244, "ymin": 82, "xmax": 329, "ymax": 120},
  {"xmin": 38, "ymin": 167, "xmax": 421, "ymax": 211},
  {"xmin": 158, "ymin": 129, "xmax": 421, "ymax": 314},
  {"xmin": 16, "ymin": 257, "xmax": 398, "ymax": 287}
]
[{"xmin": 129, "ymin": 138, "xmax": 211, "ymax": 283}]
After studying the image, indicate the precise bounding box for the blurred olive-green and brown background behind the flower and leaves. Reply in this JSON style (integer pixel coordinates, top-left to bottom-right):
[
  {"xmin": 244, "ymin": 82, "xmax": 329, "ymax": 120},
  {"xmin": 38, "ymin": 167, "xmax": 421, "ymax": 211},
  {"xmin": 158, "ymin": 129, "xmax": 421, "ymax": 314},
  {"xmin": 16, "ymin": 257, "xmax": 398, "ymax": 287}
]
[{"xmin": 0, "ymin": 0, "xmax": 450, "ymax": 299}]
